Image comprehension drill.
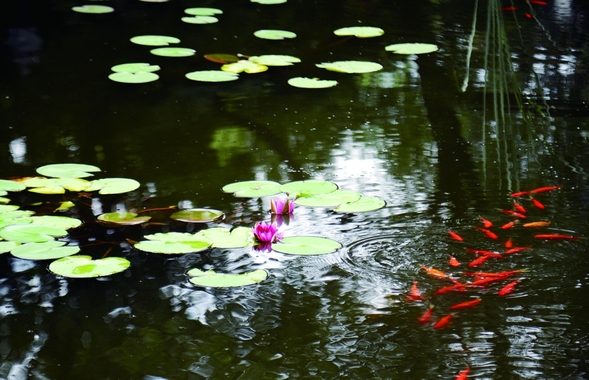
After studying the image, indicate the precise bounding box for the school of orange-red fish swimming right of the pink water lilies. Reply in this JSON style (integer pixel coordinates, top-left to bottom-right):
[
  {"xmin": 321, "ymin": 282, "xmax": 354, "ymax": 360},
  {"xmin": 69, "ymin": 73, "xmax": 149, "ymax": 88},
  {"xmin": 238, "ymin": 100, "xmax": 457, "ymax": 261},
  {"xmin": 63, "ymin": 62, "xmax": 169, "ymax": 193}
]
[{"xmin": 405, "ymin": 186, "xmax": 579, "ymax": 380}]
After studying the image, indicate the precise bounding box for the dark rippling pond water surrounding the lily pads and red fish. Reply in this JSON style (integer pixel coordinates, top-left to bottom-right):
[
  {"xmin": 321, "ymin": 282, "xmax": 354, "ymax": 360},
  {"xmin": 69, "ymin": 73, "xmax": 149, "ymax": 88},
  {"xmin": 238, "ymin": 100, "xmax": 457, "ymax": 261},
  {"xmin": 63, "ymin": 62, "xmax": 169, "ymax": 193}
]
[{"xmin": 0, "ymin": 0, "xmax": 589, "ymax": 379}]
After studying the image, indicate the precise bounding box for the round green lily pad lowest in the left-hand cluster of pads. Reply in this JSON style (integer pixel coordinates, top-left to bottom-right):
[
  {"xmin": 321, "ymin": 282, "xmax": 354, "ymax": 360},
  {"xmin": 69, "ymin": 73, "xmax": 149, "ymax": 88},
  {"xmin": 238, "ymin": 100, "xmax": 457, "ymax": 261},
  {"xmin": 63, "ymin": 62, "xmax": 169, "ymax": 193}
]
[{"xmin": 49, "ymin": 255, "xmax": 131, "ymax": 278}]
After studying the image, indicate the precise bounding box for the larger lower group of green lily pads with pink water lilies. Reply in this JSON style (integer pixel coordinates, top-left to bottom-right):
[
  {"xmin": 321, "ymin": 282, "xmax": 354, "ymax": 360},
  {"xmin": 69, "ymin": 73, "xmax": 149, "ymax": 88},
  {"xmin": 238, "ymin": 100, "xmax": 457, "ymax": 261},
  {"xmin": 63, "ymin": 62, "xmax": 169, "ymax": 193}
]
[{"xmin": 0, "ymin": 164, "xmax": 385, "ymax": 286}]
